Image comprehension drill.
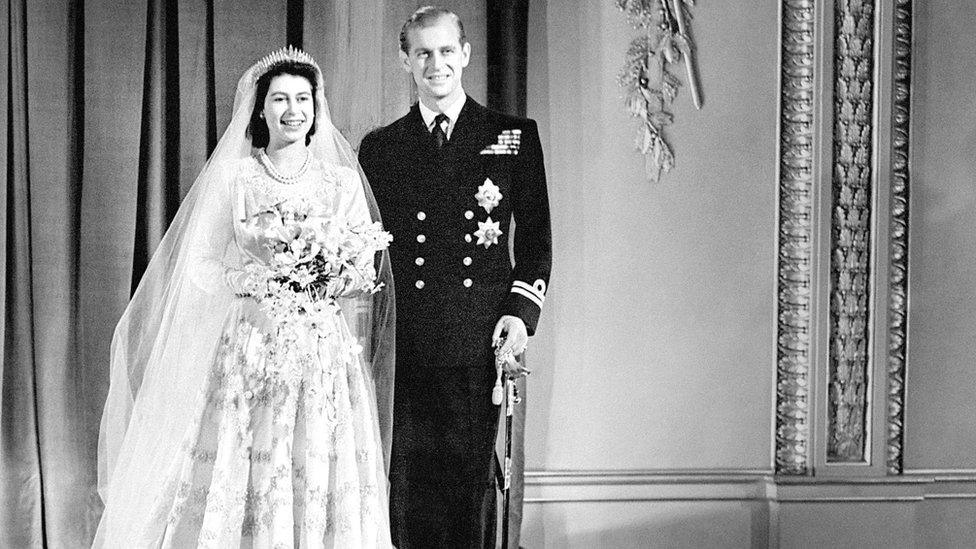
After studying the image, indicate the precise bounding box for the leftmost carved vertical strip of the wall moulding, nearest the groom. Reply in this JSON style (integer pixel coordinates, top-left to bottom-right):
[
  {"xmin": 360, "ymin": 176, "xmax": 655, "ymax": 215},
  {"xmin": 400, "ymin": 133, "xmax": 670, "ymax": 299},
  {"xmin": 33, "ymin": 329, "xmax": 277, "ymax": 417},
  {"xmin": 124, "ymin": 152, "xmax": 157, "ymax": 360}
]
[{"xmin": 776, "ymin": 0, "xmax": 814, "ymax": 475}]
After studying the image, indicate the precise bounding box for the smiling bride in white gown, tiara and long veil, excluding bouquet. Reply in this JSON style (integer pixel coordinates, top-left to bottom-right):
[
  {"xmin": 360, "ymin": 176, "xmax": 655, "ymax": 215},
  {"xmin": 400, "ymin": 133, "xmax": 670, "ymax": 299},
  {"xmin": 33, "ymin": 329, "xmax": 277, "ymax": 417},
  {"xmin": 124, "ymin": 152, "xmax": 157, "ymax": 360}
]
[{"xmin": 94, "ymin": 48, "xmax": 394, "ymax": 548}]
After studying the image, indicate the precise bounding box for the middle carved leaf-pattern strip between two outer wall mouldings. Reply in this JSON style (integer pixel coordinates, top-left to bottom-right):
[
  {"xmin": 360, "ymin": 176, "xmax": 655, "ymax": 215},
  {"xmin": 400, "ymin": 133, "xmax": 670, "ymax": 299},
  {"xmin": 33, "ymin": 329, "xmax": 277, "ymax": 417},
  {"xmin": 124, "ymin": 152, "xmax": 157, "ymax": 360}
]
[{"xmin": 827, "ymin": 0, "xmax": 874, "ymax": 463}]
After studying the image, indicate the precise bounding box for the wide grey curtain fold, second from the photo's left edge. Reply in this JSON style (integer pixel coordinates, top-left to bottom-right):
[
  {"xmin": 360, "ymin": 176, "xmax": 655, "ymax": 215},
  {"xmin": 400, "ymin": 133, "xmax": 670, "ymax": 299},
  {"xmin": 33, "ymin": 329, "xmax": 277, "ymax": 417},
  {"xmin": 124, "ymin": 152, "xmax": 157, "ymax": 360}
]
[{"xmin": 26, "ymin": 0, "xmax": 95, "ymax": 547}]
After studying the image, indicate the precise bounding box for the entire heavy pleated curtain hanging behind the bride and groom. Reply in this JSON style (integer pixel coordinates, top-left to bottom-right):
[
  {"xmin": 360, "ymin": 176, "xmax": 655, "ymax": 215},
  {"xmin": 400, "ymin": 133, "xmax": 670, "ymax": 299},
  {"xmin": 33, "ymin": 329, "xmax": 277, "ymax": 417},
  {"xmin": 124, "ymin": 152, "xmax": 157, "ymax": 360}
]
[{"xmin": 0, "ymin": 0, "xmax": 516, "ymax": 548}]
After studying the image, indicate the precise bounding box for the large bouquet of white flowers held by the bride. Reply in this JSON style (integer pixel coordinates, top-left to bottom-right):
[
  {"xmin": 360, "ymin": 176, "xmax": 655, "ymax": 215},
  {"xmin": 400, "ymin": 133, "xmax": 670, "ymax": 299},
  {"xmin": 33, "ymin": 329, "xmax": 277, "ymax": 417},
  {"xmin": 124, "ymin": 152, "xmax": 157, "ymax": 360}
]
[{"xmin": 244, "ymin": 201, "xmax": 393, "ymax": 334}]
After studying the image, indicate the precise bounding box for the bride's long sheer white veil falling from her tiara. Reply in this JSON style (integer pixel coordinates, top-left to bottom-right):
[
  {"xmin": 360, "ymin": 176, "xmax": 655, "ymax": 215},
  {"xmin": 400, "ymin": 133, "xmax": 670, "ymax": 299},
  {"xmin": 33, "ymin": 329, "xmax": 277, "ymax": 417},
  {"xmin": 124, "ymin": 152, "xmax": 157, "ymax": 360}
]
[{"xmin": 95, "ymin": 48, "xmax": 395, "ymax": 547}]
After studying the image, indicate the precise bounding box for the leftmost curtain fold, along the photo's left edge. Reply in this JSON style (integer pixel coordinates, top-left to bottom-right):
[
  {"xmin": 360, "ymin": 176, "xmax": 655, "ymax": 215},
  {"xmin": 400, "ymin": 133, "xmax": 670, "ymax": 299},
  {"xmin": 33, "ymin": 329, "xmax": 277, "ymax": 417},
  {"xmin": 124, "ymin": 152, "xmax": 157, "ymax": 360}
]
[{"xmin": 0, "ymin": 0, "xmax": 44, "ymax": 547}]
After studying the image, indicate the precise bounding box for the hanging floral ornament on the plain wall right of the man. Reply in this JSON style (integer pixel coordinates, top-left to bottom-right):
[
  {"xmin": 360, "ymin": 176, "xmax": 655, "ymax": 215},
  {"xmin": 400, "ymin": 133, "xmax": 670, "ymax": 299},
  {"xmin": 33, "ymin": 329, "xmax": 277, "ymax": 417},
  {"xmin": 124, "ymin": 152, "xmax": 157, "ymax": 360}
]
[{"xmin": 614, "ymin": 0, "xmax": 703, "ymax": 182}]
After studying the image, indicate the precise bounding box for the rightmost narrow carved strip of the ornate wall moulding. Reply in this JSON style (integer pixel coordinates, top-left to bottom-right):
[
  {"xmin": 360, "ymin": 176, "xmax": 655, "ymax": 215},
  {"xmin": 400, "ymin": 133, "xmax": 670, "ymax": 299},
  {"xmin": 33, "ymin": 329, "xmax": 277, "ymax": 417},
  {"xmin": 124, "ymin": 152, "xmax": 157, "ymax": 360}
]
[{"xmin": 887, "ymin": 0, "xmax": 912, "ymax": 475}]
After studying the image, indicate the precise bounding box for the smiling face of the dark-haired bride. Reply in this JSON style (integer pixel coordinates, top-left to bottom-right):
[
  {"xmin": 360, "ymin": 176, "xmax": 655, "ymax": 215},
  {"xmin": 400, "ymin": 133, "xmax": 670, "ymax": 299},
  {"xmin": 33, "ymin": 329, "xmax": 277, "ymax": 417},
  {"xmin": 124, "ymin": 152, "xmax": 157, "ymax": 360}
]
[{"xmin": 263, "ymin": 74, "xmax": 315, "ymax": 149}]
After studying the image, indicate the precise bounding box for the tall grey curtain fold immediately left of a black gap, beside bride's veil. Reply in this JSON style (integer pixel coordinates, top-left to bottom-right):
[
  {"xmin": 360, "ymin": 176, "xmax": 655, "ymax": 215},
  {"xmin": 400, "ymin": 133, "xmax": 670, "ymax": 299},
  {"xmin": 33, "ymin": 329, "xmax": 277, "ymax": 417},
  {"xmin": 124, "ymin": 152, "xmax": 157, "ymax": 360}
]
[{"xmin": 79, "ymin": 11, "xmax": 148, "ymax": 532}]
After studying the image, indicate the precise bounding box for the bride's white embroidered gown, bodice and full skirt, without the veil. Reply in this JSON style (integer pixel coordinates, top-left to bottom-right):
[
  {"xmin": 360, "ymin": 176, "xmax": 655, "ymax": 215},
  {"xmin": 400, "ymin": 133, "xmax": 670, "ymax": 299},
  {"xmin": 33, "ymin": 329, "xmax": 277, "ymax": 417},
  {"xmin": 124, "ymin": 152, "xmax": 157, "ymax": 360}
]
[{"xmin": 154, "ymin": 159, "xmax": 388, "ymax": 547}]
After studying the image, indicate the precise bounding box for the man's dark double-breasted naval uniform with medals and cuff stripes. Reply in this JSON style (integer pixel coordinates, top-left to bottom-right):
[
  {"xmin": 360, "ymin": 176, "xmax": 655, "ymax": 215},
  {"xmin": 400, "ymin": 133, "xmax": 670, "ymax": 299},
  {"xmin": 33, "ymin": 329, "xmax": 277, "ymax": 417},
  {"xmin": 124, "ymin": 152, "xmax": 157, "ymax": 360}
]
[{"xmin": 359, "ymin": 97, "xmax": 552, "ymax": 549}]
